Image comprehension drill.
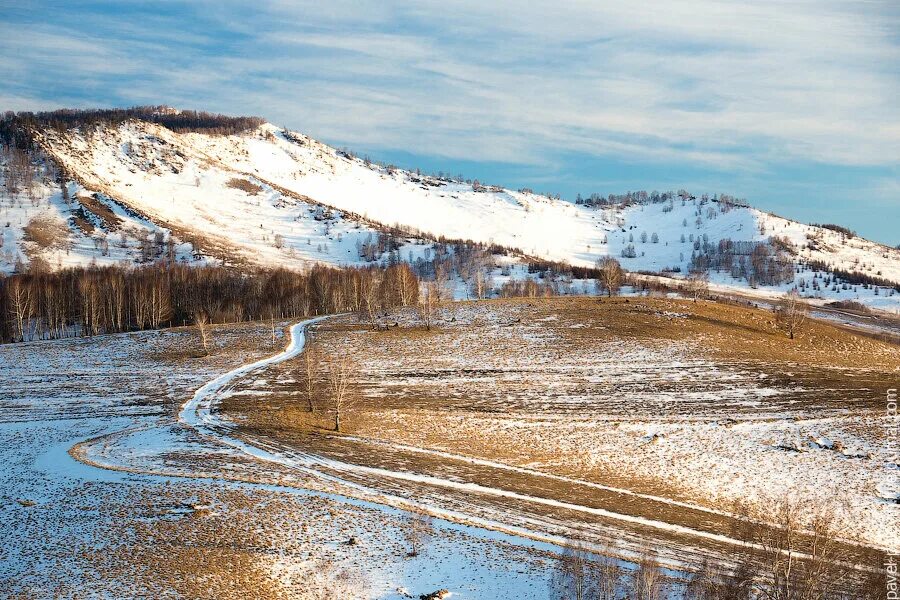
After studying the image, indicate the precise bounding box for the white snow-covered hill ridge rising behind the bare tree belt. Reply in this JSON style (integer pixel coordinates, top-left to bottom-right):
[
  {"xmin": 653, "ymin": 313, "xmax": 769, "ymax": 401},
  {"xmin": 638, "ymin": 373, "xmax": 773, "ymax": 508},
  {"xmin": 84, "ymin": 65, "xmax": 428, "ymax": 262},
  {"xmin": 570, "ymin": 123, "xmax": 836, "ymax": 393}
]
[{"xmin": 0, "ymin": 111, "xmax": 900, "ymax": 310}]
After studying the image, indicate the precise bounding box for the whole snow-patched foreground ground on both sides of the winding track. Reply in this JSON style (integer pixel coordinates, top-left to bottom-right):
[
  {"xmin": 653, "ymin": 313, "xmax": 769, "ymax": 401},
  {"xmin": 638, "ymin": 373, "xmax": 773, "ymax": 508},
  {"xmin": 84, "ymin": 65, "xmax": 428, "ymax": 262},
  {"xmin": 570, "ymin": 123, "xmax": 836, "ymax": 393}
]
[{"xmin": 0, "ymin": 298, "xmax": 898, "ymax": 598}]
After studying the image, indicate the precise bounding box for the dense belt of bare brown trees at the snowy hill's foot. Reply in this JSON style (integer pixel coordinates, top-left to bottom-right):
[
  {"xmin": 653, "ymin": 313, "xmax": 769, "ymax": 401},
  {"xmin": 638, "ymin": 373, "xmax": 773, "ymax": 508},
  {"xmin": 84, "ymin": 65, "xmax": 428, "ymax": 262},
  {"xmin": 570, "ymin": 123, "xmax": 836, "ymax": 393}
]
[{"xmin": 0, "ymin": 263, "xmax": 419, "ymax": 343}]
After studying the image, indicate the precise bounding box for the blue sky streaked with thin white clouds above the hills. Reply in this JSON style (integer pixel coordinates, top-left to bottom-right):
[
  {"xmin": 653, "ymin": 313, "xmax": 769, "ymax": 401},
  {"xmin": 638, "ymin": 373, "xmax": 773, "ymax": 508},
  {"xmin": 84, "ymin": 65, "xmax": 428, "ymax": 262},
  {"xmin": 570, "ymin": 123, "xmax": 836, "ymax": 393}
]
[{"xmin": 0, "ymin": 0, "xmax": 900, "ymax": 245}]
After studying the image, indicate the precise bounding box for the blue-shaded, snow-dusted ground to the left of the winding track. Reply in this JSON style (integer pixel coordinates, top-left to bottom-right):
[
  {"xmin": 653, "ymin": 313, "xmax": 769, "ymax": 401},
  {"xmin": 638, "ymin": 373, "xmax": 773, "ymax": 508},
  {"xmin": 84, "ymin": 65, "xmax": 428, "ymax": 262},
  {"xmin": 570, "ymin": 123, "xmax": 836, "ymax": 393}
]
[{"xmin": 0, "ymin": 316, "xmax": 640, "ymax": 598}]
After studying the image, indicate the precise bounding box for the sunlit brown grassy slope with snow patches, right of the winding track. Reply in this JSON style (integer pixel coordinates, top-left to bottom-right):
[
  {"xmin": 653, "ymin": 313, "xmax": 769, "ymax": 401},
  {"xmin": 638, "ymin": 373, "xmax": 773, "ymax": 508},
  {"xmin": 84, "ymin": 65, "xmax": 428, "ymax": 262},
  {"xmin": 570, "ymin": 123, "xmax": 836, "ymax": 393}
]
[{"xmin": 221, "ymin": 298, "xmax": 900, "ymax": 580}]
